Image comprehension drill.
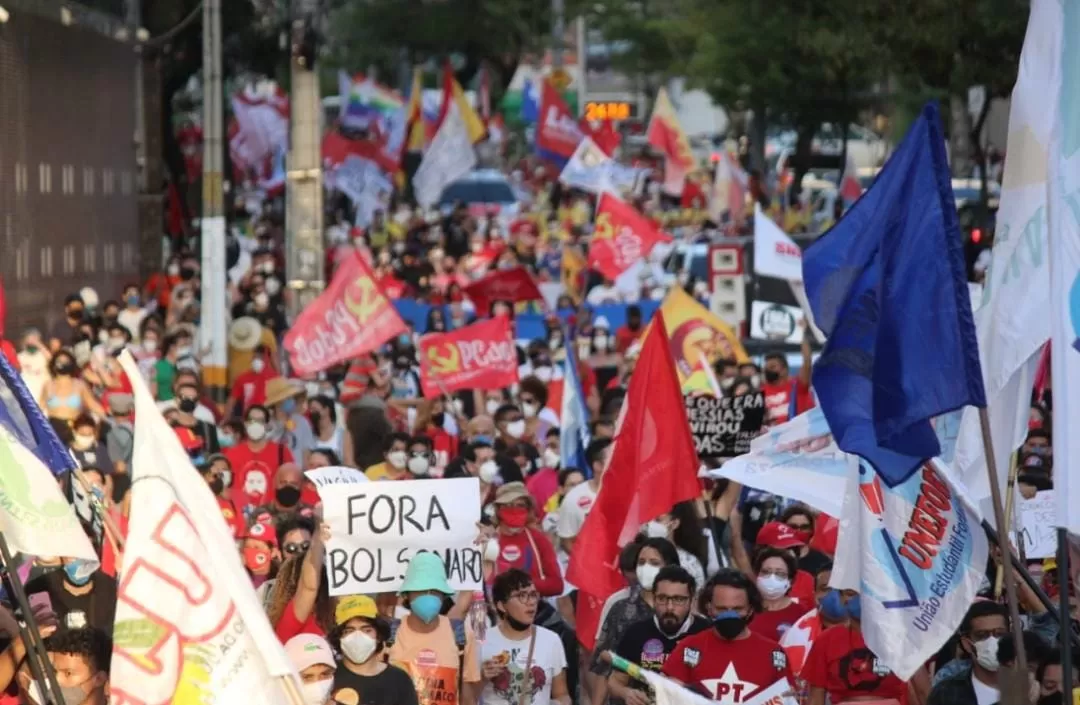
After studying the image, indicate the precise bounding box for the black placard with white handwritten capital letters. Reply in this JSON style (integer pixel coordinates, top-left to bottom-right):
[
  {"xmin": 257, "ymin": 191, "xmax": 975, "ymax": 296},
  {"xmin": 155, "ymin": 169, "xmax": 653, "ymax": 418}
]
[{"xmin": 683, "ymin": 392, "xmax": 765, "ymax": 458}]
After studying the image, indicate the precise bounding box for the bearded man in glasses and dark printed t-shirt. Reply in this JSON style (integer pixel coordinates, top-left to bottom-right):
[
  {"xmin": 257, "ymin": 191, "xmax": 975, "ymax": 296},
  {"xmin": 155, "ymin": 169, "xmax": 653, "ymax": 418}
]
[{"xmin": 608, "ymin": 566, "xmax": 708, "ymax": 705}]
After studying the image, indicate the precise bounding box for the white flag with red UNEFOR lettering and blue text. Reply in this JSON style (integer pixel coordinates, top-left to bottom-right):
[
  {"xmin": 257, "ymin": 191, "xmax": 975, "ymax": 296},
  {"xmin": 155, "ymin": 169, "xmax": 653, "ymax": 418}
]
[{"xmin": 829, "ymin": 460, "xmax": 988, "ymax": 680}]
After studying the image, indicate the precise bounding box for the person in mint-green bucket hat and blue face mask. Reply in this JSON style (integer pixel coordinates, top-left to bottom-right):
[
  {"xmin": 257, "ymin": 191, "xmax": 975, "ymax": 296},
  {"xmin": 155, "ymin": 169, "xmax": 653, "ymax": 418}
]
[{"xmin": 389, "ymin": 553, "xmax": 481, "ymax": 705}]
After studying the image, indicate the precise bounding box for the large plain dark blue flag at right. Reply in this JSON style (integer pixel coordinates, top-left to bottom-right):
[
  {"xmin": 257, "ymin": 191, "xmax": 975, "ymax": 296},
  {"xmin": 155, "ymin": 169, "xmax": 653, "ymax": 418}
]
[{"xmin": 802, "ymin": 104, "xmax": 986, "ymax": 486}]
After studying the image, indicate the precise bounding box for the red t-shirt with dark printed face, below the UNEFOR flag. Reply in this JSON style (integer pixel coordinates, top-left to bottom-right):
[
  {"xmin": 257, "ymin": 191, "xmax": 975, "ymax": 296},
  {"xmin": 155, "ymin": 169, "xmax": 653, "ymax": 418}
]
[{"xmin": 800, "ymin": 624, "xmax": 907, "ymax": 705}]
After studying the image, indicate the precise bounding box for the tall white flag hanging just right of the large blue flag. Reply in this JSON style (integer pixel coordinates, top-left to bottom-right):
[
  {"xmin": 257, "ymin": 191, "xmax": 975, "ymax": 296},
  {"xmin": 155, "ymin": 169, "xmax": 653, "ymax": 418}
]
[{"xmin": 954, "ymin": 0, "xmax": 1066, "ymax": 509}]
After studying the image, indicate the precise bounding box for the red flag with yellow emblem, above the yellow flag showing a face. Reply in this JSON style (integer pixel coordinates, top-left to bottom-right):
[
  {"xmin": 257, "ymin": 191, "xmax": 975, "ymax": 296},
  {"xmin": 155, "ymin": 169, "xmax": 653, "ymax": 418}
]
[{"xmin": 589, "ymin": 192, "xmax": 671, "ymax": 280}]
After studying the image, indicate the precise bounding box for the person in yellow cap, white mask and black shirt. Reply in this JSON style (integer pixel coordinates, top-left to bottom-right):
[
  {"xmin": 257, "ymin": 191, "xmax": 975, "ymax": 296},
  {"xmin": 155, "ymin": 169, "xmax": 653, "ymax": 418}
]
[{"xmin": 328, "ymin": 595, "xmax": 418, "ymax": 705}]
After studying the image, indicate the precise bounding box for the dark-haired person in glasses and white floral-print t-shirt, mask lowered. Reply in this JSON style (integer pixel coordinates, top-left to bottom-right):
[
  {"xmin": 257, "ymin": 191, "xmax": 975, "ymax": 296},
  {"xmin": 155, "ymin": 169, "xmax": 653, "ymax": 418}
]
[{"xmin": 481, "ymin": 568, "xmax": 570, "ymax": 705}]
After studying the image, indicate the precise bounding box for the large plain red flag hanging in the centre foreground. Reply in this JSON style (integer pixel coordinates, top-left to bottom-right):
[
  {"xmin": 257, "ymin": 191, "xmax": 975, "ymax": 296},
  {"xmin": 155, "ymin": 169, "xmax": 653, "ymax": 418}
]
[{"xmin": 566, "ymin": 311, "xmax": 701, "ymax": 638}]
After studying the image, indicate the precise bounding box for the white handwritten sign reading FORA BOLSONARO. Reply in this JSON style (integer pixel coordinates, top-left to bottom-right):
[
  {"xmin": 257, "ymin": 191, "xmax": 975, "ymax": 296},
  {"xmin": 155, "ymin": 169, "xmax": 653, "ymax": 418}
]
[{"xmin": 319, "ymin": 477, "xmax": 484, "ymax": 596}]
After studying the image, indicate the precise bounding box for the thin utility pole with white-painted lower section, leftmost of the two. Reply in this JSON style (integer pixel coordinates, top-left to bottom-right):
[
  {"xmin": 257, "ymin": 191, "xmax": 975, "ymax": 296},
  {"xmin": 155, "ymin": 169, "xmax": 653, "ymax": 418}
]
[{"xmin": 199, "ymin": 0, "xmax": 229, "ymax": 403}]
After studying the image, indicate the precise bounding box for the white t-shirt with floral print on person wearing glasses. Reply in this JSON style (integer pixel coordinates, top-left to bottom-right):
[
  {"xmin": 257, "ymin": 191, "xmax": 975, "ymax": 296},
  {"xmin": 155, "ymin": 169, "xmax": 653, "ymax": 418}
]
[{"xmin": 481, "ymin": 626, "xmax": 566, "ymax": 705}]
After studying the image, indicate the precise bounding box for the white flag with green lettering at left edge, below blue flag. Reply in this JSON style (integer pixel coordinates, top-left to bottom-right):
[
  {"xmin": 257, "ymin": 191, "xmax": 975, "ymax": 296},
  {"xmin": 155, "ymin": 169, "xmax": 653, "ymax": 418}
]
[{"xmin": 0, "ymin": 425, "xmax": 98, "ymax": 570}]
